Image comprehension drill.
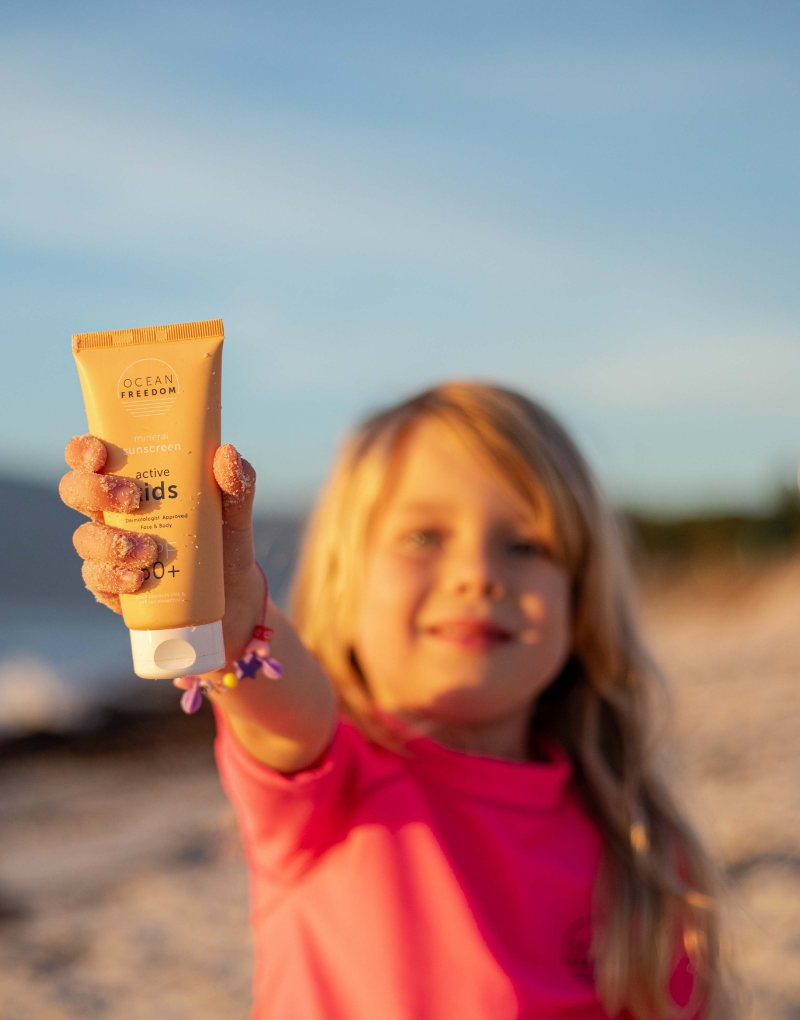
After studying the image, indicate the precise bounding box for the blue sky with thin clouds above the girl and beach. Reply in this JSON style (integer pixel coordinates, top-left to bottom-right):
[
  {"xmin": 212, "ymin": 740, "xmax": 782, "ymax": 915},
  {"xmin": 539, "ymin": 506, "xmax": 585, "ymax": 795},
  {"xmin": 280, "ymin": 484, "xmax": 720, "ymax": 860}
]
[{"xmin": 0, "ymin": 0, "xmax": 800, "ymax": 512}]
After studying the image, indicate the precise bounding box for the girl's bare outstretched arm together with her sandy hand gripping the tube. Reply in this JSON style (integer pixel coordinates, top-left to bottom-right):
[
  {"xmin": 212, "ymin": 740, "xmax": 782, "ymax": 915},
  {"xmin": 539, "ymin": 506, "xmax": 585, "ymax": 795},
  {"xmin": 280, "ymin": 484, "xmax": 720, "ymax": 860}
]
[{"xmin": 58, "ymin": 436, "xmax": 338, "ymax": 772}]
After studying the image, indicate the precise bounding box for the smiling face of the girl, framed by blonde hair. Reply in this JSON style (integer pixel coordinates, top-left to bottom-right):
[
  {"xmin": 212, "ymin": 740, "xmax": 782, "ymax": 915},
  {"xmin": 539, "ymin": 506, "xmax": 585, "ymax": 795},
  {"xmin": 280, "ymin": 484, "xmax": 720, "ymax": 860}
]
[{"xmin": 355, "ymin": 420, "xmax": 570, "ymax": 746}]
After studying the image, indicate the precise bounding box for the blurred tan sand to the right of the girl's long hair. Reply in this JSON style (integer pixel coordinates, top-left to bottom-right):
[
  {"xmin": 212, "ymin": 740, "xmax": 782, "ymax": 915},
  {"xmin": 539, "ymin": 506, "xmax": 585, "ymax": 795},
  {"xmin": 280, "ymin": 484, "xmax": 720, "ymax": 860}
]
[{"xmin": 645, "ymin": 560, "xmax": 800, "ymax": 1020}]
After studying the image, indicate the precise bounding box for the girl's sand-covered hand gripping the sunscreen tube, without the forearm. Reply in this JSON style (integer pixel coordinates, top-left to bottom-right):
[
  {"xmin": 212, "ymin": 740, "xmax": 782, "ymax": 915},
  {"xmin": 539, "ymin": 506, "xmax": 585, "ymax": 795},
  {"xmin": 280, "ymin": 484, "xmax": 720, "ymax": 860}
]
[{"xmin": 58, "ymin": 436, "xmax": 264, "ymax": 660}]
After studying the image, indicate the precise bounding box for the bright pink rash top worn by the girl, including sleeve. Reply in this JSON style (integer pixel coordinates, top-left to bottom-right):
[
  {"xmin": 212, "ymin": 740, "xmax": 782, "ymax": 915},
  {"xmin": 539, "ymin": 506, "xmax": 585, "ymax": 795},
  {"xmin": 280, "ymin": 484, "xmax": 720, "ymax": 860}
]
[{"xmin": 216, "ymin": 713, "xmax": 691, "ymax": 1020}]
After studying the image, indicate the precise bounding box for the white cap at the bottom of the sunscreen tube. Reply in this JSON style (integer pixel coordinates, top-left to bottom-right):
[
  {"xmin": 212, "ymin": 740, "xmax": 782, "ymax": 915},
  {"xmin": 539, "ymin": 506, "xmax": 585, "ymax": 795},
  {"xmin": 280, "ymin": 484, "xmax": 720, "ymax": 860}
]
[{"xmin": 131, "ymin": 620, "xmax": 226, "ymax": 680}]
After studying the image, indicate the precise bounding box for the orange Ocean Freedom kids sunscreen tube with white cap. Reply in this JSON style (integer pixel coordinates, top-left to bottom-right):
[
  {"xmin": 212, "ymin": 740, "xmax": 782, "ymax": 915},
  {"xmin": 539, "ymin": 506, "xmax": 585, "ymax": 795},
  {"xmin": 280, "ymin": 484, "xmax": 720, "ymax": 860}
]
[{"xmin": 72, "ymin": 319, "xmax": 226, "ymax": 679}]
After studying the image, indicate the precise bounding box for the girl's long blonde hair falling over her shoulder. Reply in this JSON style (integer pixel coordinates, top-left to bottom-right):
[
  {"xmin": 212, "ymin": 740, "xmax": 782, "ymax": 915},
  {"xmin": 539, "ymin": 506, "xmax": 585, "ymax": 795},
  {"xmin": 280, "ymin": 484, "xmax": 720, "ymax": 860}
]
[{"xmin": 293, "ymin": 383, "xmax": 732, "ymax": 1020}]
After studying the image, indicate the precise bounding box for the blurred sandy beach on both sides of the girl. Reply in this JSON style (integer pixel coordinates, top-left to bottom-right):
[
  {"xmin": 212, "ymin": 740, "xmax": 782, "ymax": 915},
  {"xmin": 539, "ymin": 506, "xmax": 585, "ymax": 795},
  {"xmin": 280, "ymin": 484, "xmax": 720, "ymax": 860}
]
[{"xmin": 0, "ymin": 560, "xmax": 800, "ymax": 1020}]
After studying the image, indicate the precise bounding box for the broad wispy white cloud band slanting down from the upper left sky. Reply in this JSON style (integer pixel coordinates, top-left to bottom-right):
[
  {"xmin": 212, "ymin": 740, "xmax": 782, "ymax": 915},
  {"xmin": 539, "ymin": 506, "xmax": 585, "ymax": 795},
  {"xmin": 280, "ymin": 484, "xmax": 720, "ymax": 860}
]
[{"xmin": 0, "ymin": 52, "xmax": 685, "ymax": 299}]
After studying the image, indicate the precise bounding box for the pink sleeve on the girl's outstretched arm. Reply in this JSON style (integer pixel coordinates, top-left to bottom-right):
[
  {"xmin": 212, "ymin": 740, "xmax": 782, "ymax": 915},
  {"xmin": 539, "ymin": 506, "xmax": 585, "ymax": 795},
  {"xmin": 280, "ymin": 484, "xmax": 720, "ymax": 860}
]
[{"xmin": 214, "ymin": 706, "xmax": 364, "ymax": 884}]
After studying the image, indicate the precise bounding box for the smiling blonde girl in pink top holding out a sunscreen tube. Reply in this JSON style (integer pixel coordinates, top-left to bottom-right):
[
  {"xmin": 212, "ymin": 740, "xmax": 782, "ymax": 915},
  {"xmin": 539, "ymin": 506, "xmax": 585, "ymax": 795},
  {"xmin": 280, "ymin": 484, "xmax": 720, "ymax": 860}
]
[{"xmin": 62, "ymin": 384, "xmax": 732, "ymax": 1020}]
